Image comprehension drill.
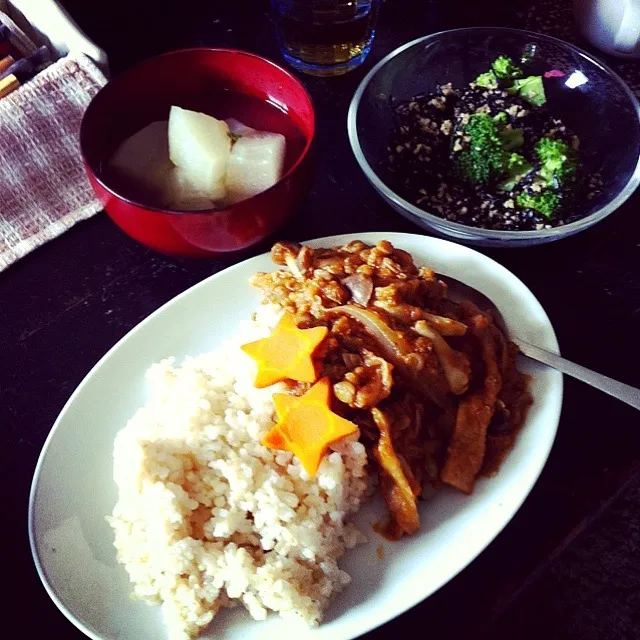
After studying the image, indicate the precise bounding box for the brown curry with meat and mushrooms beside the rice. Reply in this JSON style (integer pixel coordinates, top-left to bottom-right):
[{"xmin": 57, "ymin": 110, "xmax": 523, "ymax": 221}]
[{"xmin": 252, "ymin": 241, "xmax": 532, "ymax": 539}]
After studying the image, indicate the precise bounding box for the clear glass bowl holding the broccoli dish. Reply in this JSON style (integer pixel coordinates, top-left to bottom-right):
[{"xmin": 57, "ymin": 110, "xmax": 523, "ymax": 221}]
[{"xmin": 347, "ymin": 27, "xmax": 640, "ymax": 247}]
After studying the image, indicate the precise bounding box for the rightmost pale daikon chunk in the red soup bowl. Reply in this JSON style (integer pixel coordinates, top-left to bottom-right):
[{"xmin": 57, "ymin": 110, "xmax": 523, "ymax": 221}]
[{"xmin": 226, "ymin": 133, "xmax": 286, "ymax": 204}]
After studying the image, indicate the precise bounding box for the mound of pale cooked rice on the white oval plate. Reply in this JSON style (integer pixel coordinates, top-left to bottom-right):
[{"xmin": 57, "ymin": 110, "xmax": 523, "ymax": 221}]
[{"xmin": 108, "ymin": 307, "xmax": 366, "ymax": 640}]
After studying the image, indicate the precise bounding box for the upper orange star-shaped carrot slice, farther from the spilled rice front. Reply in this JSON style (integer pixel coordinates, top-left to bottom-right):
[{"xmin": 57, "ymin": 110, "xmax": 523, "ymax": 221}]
[{"xmin": 241, "ymin": 313, "xmax": 329, "ymax": 389}]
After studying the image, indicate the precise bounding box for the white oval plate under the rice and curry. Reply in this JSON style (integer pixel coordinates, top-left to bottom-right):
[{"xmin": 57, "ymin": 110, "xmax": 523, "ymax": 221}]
[{"xmin": 29, "ymin": 233, "xmax": 562, "ymax": 640}]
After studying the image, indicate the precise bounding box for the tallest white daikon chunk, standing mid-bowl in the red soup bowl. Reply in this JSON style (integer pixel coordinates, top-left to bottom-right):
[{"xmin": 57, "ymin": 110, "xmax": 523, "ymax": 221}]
[{"xmin": 169, "ymin": 106, "xmax": 231, "ymax": 192}]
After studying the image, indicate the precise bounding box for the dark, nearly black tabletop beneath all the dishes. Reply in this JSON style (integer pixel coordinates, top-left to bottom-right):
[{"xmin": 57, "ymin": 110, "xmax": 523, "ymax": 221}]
[{"xmin": 5, "ymin": 0, "xmax": 640, "ymax": 640}]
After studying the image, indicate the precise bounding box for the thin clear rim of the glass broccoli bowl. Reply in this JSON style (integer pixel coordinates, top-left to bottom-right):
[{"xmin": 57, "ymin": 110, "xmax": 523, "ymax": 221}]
[{"xmin": 347, "ymin": 27, "xmax": 640, "ymax": 240}]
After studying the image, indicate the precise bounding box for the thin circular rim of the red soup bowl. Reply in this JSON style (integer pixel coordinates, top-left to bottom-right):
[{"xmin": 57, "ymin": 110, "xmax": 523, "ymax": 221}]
[{"xmin": 80, "ymin": 47, "xmax": 316, "ymax": 215}]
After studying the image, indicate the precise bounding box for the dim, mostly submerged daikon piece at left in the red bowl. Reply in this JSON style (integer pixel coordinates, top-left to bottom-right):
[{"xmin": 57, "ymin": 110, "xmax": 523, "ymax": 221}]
[{"xmin": 107, "ymin": 120, "xmax": 173, "ymax": 198}]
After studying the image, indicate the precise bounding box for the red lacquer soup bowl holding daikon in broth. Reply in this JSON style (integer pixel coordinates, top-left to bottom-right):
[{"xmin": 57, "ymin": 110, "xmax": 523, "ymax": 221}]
[{"xmin": 80, "ymin": 49, "xmax": 315, "ymax": 257}]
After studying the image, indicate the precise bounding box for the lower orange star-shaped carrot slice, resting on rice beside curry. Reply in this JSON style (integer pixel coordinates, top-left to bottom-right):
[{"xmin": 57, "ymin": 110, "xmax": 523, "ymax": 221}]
[{"xmin": 262, "ymin": 378, "xmax": 358, "ymax": 478}]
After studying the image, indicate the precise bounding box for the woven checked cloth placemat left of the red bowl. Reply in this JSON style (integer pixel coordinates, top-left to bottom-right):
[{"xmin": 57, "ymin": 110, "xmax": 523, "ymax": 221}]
[{"xmin": 0, "ymin": 54, "xmax": 106, "ymax": 270}]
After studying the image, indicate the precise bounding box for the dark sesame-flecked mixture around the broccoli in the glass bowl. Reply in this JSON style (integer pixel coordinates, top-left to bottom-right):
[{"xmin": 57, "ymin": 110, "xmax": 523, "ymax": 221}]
[{"xmin": 388, "ymin": 84, "xmax": 602, "ymax": 231}]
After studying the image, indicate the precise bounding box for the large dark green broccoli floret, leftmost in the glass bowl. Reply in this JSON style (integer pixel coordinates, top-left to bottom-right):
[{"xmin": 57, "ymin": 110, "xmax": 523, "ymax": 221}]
[{"xmin": 456, "ymin": 113, "xmax": 504, "ymax": 184}]
